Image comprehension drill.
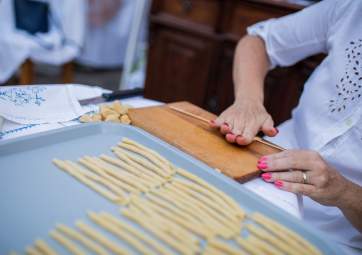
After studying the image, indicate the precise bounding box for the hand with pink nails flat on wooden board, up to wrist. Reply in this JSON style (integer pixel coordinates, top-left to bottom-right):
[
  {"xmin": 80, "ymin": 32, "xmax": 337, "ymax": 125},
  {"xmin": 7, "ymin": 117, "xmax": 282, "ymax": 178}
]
[{"xmin": 210, "ymin": 99, "xmax": 278, "ymax": 145}]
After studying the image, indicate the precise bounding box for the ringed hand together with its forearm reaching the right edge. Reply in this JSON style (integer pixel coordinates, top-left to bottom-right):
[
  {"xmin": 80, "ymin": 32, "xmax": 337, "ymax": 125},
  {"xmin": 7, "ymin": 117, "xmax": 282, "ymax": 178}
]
[{"xmin": 258, "ymin": 150, "xmax": 362, "ymax": 233}]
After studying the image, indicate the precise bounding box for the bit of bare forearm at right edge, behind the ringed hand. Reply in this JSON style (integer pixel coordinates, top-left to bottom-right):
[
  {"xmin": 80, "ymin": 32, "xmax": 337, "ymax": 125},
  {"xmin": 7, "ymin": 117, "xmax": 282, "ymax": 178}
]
[{"xmin": 337, "ymin": 181, "xmax": 362, "ymax": 233}]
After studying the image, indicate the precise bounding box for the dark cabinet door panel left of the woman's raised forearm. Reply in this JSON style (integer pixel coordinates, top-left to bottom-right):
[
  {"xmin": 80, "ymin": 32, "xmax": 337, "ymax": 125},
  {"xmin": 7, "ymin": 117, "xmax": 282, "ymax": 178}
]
[{"xmin": 145, "ymin": 28, "xmax": 214, "ymax": 106}]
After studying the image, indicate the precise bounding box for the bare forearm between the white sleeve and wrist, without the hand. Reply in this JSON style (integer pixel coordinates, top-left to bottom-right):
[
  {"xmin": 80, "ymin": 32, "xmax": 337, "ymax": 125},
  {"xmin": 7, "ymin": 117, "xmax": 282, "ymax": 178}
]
[{"xmin": 233, "ymin": 35, "xmax": 269, "ymax": 103}]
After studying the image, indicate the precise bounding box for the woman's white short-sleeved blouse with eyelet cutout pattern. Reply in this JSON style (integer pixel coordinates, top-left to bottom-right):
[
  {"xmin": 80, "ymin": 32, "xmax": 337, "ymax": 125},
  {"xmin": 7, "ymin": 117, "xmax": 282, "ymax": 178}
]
[{"xmin": 248, "ymin": 0, "xmax": 362, "ymax": 254}]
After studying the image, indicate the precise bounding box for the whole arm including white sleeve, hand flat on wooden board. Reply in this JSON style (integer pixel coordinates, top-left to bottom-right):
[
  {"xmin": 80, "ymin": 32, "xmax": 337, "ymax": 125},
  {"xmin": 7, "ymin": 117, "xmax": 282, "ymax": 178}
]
[{"xmin": 211, "ymin": 0, "xmax": 337, "ymax": 145}]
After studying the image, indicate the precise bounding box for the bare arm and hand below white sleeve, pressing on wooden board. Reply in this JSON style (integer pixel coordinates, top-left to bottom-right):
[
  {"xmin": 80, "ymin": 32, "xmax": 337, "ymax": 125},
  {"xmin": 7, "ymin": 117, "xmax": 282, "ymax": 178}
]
[{"xmin": 213, "ymin": 36, "xmax": 277, "ymax": 145}]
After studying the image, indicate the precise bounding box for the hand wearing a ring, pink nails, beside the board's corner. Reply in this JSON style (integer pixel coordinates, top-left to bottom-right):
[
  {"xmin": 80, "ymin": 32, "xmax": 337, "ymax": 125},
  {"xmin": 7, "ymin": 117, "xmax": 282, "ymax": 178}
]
[{"xmin": 258, "ymin": 150, "xmax": 348, "ymax": 206}]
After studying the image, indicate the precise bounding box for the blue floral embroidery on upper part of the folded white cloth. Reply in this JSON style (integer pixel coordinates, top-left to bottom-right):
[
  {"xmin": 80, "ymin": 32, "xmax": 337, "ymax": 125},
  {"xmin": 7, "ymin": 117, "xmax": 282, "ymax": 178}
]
[{"xmin": 0, "ymin": 86, "xmax": 47, "ymax": 106}]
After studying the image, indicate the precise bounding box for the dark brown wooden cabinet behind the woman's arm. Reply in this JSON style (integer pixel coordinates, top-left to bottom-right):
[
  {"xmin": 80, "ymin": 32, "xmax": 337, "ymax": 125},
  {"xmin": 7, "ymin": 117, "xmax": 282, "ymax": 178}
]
[{"xmin": 145, "ymin": 0, "xmax": 321, "ymax": 123}]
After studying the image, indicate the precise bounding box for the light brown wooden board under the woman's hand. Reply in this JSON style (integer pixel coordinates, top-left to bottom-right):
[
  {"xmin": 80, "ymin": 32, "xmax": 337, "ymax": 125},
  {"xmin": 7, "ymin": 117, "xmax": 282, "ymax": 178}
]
[{"xmin": 129, "ymin": 102, "xmax": 279, "ymax": 182}]
